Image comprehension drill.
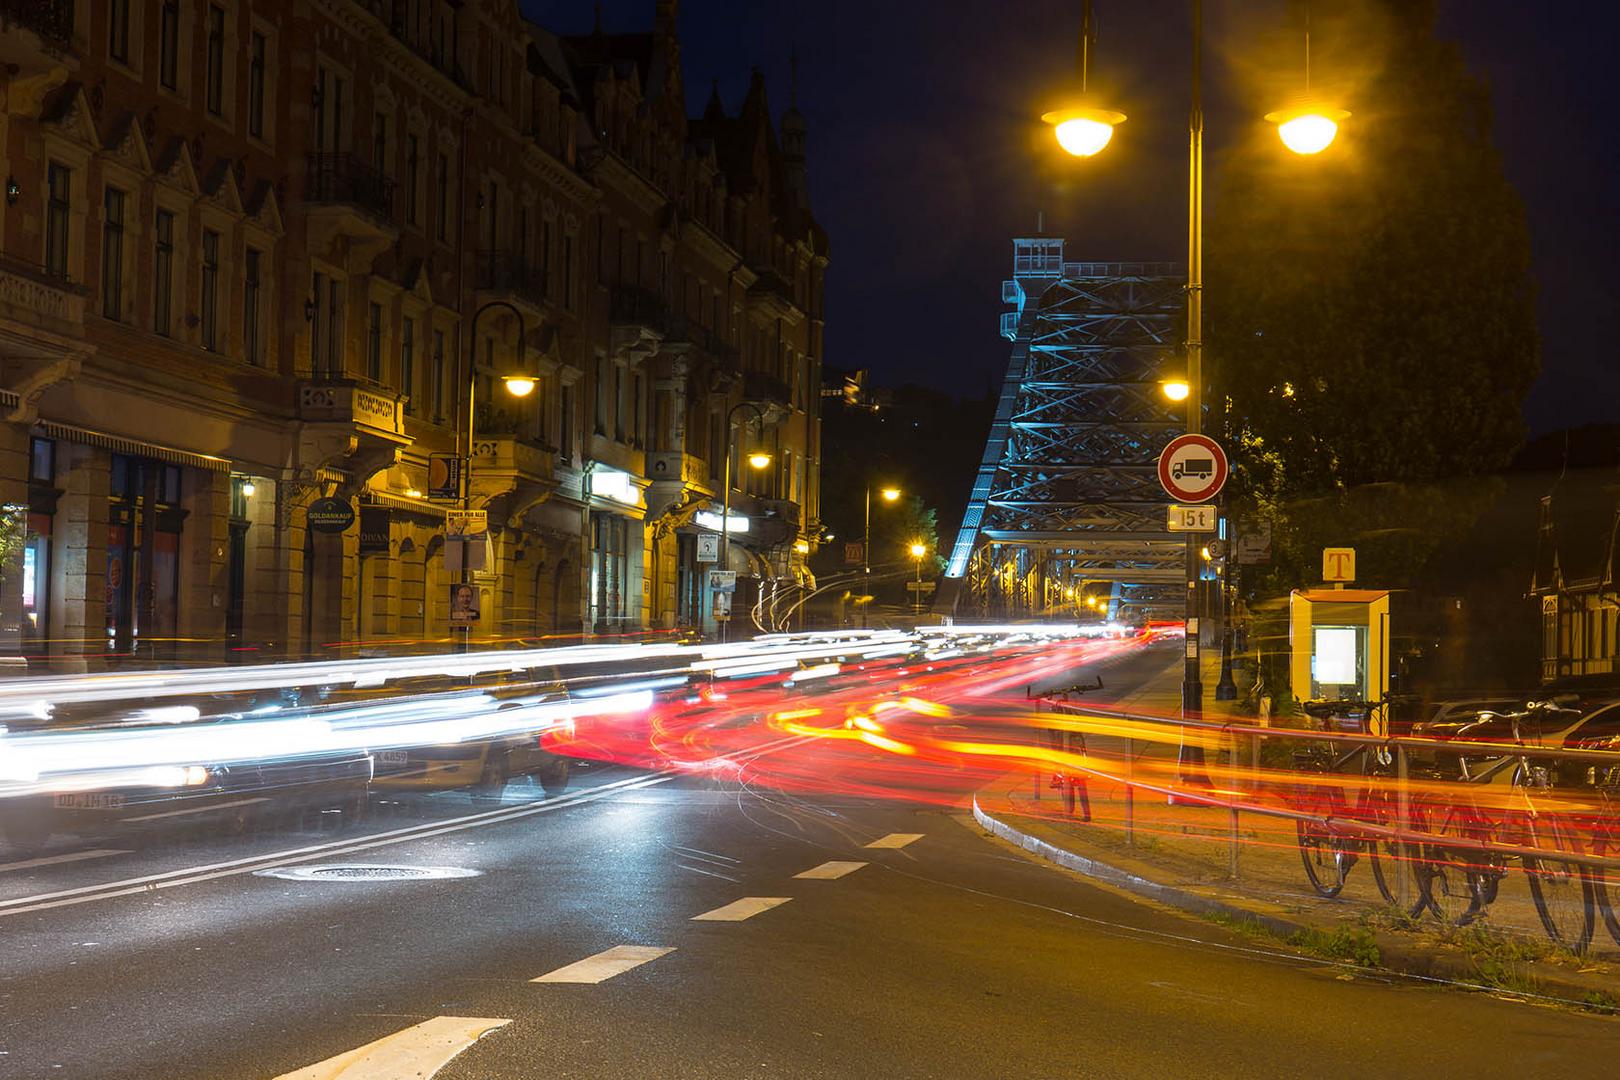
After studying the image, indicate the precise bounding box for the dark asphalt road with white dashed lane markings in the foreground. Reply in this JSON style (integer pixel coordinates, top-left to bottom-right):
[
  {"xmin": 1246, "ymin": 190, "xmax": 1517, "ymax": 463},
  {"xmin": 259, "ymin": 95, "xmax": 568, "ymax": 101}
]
[{"xmin": 0, "ymin": 647, "xmax": 1620, "ymax": 1080}]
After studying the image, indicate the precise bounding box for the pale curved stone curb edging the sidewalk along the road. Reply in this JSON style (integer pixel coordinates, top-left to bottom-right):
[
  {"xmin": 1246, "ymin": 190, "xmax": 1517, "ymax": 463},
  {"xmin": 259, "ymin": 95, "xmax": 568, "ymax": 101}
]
[{"xmin": 974, "ymin": 793, "xmax": 1612, "ymax": 1012}]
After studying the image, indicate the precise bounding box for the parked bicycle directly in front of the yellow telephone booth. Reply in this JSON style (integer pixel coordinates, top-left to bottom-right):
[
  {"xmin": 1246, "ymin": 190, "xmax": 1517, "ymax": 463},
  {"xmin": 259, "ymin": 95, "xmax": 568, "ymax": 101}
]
[{"xmin": 1290, "ymin": 698, "xmax": 1422, "ymax": 915}]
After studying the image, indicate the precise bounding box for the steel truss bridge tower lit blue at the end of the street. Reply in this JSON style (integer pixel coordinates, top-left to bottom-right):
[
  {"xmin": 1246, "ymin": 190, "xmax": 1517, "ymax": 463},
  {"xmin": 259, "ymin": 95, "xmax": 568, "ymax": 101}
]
[{"xmin": 936, "ymin": 236, "xmax": 1186, "ymax": 620}]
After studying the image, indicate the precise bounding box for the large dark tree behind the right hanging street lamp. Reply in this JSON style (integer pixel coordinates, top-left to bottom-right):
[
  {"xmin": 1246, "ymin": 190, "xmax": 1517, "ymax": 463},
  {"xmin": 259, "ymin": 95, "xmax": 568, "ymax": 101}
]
[{"xmin": 1205, "ymin": 0, "xmax": 1539, "ymax": 508}]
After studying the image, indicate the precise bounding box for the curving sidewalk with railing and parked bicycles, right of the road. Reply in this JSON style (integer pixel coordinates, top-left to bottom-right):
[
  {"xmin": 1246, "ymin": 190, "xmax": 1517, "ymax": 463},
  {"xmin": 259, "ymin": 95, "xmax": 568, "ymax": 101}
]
[{"xmin": 974, "ymin": 657, "xmax": 1620, "ymax": 1004}]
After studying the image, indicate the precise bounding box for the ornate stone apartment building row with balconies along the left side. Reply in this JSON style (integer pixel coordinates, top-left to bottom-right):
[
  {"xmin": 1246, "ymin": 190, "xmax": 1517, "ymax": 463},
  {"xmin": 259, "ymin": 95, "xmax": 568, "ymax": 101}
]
[{"xmin": 0, "ymin": 0, "xmax": 828, "ymax": 665}]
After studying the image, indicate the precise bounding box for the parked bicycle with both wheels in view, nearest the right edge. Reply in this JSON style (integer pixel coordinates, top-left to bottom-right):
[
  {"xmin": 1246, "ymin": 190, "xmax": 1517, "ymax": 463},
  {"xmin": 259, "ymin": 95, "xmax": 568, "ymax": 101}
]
[{"xmin": 1413, "ymin": 701, "xmax": 1597, "ymax": 952}]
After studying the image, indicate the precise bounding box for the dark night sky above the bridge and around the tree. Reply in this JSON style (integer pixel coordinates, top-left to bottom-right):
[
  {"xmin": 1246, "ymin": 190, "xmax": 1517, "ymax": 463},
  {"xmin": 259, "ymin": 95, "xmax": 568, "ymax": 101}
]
[{"xmin": 525, "ymin": 0, "xmax": 1620, "ymax": 431}]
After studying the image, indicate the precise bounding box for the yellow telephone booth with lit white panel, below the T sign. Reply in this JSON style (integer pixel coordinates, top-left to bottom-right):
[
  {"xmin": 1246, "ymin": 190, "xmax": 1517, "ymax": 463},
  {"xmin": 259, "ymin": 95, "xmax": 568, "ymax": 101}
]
[{"xmin": 1288, "ymin": 589, "xmax": 1390, "ymax": 725}]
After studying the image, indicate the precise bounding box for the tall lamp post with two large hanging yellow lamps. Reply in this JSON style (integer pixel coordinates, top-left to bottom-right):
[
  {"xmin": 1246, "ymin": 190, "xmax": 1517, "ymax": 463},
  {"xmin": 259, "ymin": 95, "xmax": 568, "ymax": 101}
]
[{"xmin": 1042, "ymin": 0, "xmax": 1349, "ymax": 785}]
